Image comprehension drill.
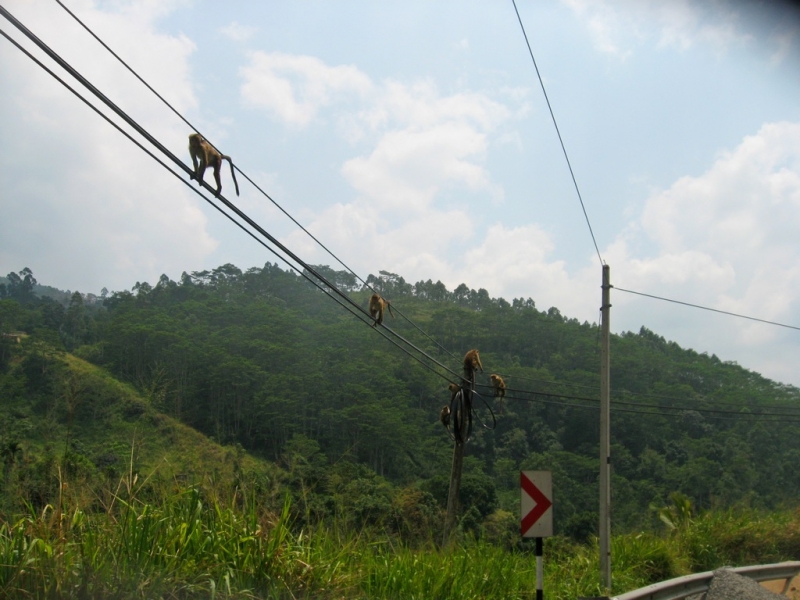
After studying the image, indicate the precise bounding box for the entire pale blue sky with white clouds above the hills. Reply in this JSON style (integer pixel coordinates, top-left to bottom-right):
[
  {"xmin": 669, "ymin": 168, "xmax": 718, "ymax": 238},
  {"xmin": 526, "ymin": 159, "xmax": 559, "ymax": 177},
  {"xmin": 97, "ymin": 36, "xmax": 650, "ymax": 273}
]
[{"xmin": 0, "ymin": 0, "xmax": 800, "ymax": 385}]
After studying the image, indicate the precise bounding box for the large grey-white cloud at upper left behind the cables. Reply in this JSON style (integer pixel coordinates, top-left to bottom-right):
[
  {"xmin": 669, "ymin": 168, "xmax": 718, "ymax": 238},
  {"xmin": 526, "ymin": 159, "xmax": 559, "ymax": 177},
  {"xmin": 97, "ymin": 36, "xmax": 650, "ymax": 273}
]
[{"xmin": 0, "ymin": 2, "xmax": 216, "ymax": 292}]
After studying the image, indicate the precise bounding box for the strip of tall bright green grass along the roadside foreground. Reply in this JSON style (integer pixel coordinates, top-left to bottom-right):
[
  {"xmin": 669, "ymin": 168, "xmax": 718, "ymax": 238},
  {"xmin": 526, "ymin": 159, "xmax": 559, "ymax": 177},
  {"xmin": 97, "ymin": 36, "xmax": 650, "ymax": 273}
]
[{"xmin": 0, "ymin": 479, "xmax": 800, "ymax": 600}]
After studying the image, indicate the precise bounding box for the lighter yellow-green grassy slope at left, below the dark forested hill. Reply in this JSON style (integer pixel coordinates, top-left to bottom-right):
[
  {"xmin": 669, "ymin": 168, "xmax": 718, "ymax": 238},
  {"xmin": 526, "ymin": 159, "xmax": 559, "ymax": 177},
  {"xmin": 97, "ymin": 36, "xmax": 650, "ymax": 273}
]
[{"xmin": 0, "ymin": 335, "xmax": 277, "ymax": 512}]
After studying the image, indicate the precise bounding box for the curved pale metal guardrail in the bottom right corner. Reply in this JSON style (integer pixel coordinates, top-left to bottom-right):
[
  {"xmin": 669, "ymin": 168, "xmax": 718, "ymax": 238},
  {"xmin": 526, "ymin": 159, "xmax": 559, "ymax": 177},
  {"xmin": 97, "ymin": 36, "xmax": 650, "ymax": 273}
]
[{"xmin": 612, "ymin": 561, "xmax": 800, "ymax": 600}]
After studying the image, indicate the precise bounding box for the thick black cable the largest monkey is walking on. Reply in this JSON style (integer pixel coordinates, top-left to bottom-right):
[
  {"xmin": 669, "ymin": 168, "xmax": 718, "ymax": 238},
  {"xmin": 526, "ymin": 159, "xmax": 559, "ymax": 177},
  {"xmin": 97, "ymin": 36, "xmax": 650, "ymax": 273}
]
[{"xmin": 0, "ymin": 6, "xmax": 456, "ymax": 378}]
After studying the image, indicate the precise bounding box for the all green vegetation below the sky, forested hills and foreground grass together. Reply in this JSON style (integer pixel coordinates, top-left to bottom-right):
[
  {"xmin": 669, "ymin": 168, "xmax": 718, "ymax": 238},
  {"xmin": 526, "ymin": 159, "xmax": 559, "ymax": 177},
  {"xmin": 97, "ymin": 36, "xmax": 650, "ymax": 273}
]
[{"xmin": 0, "ymin": 264, "xmax": 800, "ymax": 598}]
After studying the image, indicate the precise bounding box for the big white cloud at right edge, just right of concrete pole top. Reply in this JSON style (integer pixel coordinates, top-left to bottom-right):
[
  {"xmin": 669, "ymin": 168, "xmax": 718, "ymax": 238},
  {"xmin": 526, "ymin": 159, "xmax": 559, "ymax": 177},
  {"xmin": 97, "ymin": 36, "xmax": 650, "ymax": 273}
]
[{"xmin": 604, "ymin": 122, "xmax": 800, "ymax": 380}]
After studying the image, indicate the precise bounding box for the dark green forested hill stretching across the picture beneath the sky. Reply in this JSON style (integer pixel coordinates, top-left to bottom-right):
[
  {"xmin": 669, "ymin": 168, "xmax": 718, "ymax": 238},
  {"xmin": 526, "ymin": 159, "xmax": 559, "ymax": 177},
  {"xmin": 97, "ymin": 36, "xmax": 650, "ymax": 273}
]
[{"xmin": 0, "ymin": 263, "xmax": 800, "ymax": 537}]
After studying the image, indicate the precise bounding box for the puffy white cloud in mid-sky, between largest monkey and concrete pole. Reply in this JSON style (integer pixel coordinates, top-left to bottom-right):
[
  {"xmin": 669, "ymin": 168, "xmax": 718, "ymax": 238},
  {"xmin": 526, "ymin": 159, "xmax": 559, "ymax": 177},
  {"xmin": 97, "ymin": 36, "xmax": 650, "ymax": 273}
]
[{"xmin": 242, "ymin": 54, "xmax": 521, "ymax": 285}]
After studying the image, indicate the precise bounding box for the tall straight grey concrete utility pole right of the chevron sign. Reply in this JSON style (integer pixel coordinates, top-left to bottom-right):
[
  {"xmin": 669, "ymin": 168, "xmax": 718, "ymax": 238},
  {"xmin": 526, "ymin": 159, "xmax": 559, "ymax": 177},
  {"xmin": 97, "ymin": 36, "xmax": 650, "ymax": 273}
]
[{"xmin": 600, "ymin": 265, "xmax": 611, "ymax": 590}]
